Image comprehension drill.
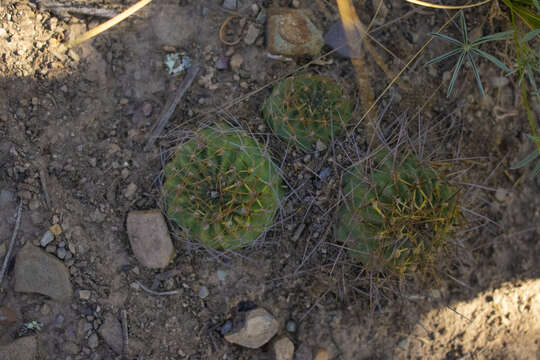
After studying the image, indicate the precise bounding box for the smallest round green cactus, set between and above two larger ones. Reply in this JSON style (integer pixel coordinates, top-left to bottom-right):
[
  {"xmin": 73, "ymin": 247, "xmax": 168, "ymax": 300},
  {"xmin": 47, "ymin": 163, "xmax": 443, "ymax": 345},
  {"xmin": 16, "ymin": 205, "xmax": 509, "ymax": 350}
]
[{"xmin": 263, "ymin": 74, "xmax": 351, "ymax": 150}]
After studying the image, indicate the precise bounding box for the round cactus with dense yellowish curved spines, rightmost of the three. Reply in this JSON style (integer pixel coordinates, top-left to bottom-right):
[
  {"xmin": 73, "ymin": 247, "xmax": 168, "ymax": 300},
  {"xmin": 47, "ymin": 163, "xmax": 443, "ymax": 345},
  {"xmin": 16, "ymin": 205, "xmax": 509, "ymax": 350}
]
[{"xmin": 337, "ymin": 151, "xmax": 459, "ymax": 276}]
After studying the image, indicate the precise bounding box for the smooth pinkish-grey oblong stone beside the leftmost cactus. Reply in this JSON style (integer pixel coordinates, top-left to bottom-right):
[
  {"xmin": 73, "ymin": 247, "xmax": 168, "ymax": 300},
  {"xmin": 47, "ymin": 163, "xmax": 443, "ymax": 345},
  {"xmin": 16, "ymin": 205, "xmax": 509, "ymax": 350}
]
[{"xmin": 127, "ymin": 209, "xmax": 174, "ymax": 269}]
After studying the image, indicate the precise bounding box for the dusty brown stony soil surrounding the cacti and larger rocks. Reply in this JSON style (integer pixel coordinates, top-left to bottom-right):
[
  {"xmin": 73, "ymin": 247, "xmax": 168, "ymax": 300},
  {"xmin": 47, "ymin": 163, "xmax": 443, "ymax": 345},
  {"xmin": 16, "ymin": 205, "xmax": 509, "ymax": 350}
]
[{"xmin": 0, "ymin": 0, "xmax": 540, "ymax": 360}]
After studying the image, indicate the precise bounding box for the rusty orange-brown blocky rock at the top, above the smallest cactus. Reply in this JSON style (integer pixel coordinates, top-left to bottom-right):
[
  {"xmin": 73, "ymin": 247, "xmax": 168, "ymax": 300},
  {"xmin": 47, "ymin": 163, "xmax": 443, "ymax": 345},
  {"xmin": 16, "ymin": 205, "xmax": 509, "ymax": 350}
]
[{"xmin": 267, "ymin": 8, "xmax": 324, "ymax": 56}]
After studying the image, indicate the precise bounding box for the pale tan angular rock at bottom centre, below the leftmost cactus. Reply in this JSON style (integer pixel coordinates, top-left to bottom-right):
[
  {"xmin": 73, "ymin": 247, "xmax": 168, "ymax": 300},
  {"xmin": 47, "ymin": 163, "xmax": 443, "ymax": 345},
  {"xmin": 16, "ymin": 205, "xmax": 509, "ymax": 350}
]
[{"xmin": 225, "ymin": 308, "xmax": 279, "ymax": 349}]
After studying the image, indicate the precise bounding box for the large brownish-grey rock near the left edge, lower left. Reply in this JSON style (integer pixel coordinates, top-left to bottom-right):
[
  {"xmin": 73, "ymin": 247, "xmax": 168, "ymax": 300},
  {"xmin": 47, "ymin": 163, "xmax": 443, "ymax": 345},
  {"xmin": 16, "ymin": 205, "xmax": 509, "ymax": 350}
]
[{"xmin": 15, "ymin": 244, "xmax": 73, "ymax": 302}]
